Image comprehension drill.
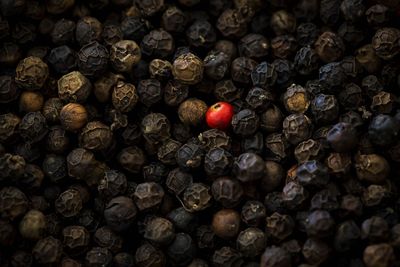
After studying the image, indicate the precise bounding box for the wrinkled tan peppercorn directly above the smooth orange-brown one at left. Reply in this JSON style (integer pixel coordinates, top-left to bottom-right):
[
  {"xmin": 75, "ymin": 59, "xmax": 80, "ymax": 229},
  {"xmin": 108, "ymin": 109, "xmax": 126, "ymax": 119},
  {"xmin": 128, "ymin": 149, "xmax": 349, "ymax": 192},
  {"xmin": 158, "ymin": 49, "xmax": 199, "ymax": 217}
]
[{"xmin": 58, "ymin": 71, "xmax": 92, "ymax": 103}]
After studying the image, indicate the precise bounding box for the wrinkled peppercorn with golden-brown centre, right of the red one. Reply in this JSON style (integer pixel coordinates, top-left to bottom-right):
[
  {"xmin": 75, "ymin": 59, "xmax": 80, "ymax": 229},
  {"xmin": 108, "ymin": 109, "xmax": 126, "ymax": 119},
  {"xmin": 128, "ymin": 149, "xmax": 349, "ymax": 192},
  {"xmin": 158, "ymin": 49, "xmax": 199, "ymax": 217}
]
[{"xmin": 283, "ymin": 84, "xmax": 310, "ymax": 113}]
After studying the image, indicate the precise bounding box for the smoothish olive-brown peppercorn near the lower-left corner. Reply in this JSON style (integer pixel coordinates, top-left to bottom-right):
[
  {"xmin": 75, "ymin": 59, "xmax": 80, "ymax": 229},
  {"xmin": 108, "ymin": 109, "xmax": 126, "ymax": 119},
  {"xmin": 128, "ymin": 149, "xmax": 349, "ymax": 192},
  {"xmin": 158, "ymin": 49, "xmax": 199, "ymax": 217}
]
[{"xmin": 19, "ymin": 210, "xmax": 46, "ymax": 240}]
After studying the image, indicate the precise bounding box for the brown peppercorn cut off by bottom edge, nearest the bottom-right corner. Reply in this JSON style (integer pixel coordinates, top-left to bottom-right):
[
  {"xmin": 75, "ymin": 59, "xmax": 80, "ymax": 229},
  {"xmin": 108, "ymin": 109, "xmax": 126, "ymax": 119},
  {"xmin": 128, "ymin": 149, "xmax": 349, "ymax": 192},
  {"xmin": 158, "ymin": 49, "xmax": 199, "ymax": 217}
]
[{"xmin": 363, "ymin": 243, "xmax": 395, "ymax": 267}]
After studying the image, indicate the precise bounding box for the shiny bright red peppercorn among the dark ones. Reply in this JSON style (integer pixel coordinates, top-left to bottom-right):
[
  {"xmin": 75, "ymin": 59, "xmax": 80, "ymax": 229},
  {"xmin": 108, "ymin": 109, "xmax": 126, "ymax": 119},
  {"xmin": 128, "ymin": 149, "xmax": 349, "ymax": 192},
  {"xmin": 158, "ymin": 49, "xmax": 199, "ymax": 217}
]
[{"xmin": 206, "ymin": 102, "xmax": 233, "ymax": 130}]
